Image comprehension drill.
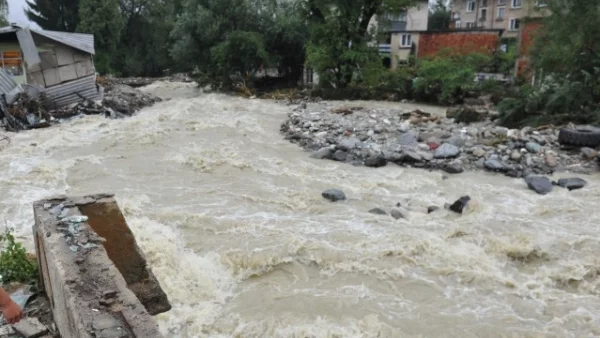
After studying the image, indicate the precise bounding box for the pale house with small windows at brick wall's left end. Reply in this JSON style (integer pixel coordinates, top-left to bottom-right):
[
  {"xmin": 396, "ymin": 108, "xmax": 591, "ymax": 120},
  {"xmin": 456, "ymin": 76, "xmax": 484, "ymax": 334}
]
[{"xmin": 371, "ymin": 0, "xmax": 429, "ymax": 69}]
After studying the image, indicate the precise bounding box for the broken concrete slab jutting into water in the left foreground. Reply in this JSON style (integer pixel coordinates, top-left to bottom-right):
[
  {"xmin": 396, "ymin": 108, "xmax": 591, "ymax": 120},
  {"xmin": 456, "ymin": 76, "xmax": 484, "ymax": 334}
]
[{"xmin": 33, "ymin": 194, "xmax": 171, "ymax": 338}]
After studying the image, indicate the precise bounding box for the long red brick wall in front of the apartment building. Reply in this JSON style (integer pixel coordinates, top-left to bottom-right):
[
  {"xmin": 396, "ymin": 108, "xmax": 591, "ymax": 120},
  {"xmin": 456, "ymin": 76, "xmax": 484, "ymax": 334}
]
[{"xmin": 417, "ymin": 31, "xmax": 500, "ymax": 57}]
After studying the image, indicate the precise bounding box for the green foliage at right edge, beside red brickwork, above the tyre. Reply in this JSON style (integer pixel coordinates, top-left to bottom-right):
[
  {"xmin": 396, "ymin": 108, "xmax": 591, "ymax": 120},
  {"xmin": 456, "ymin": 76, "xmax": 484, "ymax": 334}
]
[{"xmin": 499, "ymin": 0, "xmax": 600, "ymax": 126}]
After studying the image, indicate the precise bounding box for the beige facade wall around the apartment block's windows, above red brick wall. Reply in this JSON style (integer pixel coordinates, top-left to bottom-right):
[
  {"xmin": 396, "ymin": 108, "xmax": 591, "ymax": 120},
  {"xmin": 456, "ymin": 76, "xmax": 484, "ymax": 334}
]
[{"xmin": 452, "ymin": 0, "xmax": 549, "ymax": 38}]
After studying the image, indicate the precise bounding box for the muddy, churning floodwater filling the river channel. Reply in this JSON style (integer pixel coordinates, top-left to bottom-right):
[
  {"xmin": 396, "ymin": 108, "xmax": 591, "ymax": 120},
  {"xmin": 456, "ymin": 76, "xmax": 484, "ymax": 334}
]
[{"xmin": 0, "ymin": 83, "xmax": 600, "ymax": 338}]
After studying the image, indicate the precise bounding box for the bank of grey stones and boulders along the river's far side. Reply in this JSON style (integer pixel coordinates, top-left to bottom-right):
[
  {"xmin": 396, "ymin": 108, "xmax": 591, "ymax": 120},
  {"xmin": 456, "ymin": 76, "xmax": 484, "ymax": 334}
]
[{"xmin": 281, "ymin": 102, "xmax": 598, "ymax": 177}]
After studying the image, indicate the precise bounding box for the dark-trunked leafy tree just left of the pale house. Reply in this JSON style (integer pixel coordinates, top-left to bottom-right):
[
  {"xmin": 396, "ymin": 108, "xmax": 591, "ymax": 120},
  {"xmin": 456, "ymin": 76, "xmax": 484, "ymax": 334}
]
[{"xmin": 303, "ymin": 0, "xmax": 413, "ymax": 88}]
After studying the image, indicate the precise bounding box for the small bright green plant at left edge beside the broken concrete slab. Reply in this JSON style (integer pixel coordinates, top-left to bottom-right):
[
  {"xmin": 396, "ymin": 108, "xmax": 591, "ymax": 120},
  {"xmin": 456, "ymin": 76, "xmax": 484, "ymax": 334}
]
[{"xmin": 0, "ymin": 231, "xmax": 38, "ymax": 283}]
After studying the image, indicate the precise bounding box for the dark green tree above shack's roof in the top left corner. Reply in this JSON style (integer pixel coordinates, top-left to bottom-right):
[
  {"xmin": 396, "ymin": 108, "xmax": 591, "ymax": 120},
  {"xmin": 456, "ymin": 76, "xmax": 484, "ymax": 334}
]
[{"xmin": 25, "ymin": 0, "xmax": 79, "ymax": 32}]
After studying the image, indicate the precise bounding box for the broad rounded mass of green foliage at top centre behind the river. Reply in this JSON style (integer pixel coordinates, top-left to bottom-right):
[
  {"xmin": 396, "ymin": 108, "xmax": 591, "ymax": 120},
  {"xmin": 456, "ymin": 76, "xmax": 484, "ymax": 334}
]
[{"xmin": 171, "ymin": 0, "xmax": 308, "ymax": 87}]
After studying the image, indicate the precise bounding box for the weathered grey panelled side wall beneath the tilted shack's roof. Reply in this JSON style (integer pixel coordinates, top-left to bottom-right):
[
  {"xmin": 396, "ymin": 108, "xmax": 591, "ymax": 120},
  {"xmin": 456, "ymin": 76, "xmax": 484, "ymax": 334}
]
[{"xmin": 27, "ymin": 36, "xmax": 95, "ymax": 87}]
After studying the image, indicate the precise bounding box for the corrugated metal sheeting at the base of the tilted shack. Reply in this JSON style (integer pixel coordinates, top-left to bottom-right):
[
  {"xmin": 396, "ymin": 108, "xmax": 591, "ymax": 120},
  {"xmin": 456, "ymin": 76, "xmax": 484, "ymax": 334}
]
[{"xmin": 45, "ymin": 75, "xmax": 101, "ymax": 107}]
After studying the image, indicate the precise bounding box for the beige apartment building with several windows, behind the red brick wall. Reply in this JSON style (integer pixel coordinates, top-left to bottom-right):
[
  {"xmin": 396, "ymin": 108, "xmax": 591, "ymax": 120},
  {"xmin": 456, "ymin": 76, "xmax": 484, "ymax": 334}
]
[{"xmin": 452, "ymin": 0, "xmax": 549, "ymax": 38}]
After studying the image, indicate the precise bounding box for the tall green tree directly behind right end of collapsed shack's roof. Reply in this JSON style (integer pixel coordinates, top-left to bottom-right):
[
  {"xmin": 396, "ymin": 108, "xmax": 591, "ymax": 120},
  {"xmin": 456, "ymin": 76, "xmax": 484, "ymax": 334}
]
[{"xmin": 77, "ymin": 0, "xmax": 123, "ymax": 73}]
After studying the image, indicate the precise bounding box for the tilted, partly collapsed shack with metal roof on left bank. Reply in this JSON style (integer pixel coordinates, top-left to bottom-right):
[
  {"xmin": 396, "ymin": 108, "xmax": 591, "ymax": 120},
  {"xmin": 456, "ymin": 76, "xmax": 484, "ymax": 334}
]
[{"xmin": 0, "ymin": 25, "xmax": 104, "ymax": 129}]
